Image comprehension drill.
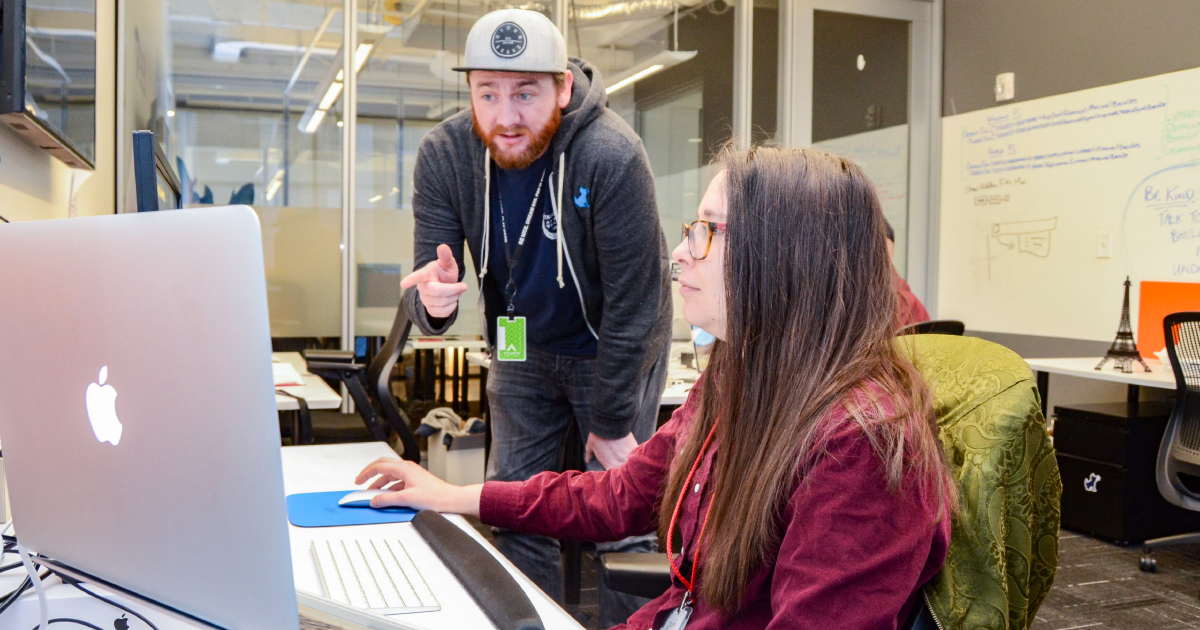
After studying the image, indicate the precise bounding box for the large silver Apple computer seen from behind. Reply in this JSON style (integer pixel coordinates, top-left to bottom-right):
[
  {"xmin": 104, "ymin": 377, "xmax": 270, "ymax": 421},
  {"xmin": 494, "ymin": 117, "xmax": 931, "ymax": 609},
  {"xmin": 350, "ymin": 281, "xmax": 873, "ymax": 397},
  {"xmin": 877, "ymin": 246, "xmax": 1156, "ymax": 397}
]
[{"xmin": 0, "ymin": 206, "xmax": 299, "ymax": 630}]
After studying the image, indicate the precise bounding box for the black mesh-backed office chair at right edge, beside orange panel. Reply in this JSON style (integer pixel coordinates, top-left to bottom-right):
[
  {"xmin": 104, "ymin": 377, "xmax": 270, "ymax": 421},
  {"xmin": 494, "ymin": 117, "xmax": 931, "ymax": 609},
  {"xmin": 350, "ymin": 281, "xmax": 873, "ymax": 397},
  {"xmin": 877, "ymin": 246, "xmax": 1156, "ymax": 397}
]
[{"xmin": 1139, "ymin": 312, "xmax": 1200, "ymax": 572}]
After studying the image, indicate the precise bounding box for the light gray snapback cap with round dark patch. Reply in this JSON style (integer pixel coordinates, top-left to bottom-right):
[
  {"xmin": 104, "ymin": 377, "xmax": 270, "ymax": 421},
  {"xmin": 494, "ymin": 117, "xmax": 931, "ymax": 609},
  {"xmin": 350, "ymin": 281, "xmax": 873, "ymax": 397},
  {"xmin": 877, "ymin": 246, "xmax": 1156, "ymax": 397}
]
[{"xmin": 454, "ymin": 8, "xmax": 566, "ymax": 73}]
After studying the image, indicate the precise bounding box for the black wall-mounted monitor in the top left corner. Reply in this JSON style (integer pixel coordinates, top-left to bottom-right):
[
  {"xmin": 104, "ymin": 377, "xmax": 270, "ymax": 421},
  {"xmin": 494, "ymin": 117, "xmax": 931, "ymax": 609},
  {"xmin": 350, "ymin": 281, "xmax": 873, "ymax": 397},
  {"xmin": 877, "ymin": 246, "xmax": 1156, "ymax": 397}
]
[{"xmin": 0, "ymin": 0, "xmax": 96, "ymax": 170}]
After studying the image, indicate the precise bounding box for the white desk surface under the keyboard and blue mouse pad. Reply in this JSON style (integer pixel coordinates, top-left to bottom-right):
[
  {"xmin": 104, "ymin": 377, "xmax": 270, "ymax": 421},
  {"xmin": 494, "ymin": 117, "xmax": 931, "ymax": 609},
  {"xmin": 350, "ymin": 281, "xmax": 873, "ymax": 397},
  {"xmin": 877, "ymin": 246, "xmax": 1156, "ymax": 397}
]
[{"xmin": 283, "ymin": 442, "xmax": 582, "ymax": 630}]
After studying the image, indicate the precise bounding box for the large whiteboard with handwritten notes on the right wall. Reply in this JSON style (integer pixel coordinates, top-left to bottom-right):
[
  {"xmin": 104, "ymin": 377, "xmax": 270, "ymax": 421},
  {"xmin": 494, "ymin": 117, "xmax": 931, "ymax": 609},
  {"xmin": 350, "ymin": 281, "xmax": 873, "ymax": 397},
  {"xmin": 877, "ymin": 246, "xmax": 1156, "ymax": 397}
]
[{"xmin": 937, "ymin": 68, "xmax": 1200, "ymax": 341}]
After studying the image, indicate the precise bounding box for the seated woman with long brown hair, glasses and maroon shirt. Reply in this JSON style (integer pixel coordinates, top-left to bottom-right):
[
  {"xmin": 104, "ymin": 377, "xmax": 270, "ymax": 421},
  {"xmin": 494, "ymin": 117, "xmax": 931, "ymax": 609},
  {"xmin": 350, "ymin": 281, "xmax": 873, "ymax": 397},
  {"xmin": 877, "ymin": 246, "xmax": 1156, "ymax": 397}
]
[{"xmin": 356, "ymin": 149, "xmax": 955, "ymax": 630}]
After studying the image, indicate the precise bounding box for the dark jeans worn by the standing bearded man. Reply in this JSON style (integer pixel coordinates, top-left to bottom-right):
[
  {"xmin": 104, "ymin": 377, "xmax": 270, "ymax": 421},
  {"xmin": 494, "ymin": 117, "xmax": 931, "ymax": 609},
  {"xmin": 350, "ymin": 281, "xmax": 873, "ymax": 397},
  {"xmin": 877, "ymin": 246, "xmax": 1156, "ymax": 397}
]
[{"xmin": 487, "ymin": 347, "xmax": 668, "ymax": 628}]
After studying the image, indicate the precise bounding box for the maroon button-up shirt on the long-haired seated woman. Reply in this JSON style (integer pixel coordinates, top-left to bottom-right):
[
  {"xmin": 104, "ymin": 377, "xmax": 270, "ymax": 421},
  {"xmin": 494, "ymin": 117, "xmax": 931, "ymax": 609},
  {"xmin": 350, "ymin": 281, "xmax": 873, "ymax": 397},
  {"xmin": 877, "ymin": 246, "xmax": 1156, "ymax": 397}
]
[{"xmin": 479, "ymin": 390, "xmax": 950, "ymax": 630}]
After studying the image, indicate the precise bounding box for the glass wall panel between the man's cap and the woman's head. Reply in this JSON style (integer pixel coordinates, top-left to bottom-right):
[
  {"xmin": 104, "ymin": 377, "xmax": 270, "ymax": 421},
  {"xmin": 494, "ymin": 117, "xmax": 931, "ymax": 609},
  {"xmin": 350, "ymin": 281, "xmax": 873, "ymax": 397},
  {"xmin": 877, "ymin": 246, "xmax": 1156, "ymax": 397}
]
[{"xmin": 568, "ymin": 0, "xmax": 734, "ymax": 338}]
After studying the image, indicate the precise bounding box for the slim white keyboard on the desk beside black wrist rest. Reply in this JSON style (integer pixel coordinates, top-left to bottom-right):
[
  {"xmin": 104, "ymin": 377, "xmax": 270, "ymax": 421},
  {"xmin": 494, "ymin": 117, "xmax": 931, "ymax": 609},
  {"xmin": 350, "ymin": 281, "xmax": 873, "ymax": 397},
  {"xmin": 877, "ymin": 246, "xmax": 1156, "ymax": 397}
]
[{"xmin": 312, "ymin": 539, "xmax": 442, "ymax": 614}]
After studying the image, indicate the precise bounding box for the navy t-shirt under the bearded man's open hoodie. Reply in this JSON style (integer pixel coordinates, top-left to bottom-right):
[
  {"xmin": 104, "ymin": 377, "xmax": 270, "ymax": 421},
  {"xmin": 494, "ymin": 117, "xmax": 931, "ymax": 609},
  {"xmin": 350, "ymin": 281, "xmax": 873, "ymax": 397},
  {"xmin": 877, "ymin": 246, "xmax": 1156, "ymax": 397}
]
[{"xmin": 484, "ymin": 151, "xmax": 596, "ymax": 356}]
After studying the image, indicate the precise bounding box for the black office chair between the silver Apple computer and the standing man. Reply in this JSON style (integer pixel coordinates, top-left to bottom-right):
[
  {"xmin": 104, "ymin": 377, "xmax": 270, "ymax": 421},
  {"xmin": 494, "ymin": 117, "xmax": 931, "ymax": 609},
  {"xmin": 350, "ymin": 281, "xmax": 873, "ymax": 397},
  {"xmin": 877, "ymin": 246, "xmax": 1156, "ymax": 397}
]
[{"xmin": 293, "ymin": 302, "xmax": 421, "ymax": 462}]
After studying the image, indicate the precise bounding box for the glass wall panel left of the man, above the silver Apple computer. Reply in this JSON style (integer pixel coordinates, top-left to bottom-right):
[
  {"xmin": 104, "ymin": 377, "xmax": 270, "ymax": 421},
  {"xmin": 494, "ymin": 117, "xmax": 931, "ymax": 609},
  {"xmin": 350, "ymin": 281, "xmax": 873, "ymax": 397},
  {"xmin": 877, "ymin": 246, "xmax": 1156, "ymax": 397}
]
[{"xmin": 162, "ymin": 0, "xmax": 342, "ymax": 343}]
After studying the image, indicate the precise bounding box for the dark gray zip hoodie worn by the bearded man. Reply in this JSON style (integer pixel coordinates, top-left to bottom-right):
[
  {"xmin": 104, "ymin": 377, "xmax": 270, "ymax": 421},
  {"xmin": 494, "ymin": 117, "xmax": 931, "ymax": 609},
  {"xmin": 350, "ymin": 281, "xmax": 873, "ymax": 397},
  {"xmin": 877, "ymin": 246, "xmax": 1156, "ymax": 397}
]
[{"xmin": 402, "ymin": 58, "xmax": 671, "ymax": 439}]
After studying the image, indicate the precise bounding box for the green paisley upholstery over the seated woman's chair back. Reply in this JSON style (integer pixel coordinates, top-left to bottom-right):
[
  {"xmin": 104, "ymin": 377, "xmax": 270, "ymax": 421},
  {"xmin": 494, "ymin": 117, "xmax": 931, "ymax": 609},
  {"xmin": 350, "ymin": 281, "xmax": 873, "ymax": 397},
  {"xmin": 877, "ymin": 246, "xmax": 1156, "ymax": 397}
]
[{"xmin": 898, "ymin": 335, "xmax": 1062, "ymax": 630}]
